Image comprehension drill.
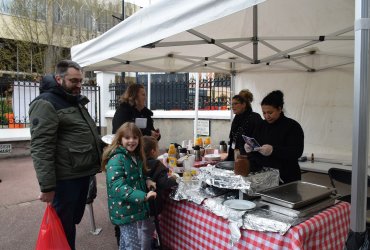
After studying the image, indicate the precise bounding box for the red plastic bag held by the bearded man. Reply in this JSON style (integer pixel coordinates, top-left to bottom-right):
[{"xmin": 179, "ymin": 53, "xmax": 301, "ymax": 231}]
[{"xmin": 36, "ymin": 204, "xmax": 71, "ymax": 250}]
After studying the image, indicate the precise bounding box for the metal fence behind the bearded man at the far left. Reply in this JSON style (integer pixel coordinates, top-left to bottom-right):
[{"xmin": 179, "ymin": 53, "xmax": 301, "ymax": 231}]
[{"xmin": 0, "ymin": 79, "xmax": 101, "ymax": 128}]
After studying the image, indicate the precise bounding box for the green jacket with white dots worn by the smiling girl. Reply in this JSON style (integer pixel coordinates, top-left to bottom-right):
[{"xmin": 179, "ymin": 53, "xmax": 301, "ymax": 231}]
[{"xmin": 106, "ymin": 146, "xmax": 149, "ymax": 225}]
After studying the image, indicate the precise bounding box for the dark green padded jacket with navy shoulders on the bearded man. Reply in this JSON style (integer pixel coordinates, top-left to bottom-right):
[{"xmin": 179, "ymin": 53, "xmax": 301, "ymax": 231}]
[{"xmin": 29, "ymin": 77, "xmax": 102, "ymax": 192}]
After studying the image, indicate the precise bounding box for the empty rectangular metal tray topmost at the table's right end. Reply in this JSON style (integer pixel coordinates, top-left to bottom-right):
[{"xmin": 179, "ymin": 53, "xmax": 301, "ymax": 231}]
[{"xmin": 258, "ymin": 181, "xmax": 334, "ymax": 208}]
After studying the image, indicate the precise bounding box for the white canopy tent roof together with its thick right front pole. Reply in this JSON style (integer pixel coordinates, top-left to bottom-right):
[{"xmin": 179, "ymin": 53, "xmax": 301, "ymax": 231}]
[{"xmin": 72, "ymin": 0, "xmax": 370, "ymax": 244}]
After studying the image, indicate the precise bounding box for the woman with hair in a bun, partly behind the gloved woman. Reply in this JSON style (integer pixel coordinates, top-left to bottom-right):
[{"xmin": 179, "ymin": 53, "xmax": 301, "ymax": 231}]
[{"xmin": 226, "ymin": 89, "xmax": 262, "ymax": 161}]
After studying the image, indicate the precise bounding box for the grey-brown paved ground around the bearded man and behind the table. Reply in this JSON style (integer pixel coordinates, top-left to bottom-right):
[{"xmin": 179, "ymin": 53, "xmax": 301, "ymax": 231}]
[{"xmin": 0, "ymin": 157, "xmax": 349, "ymax": 250}]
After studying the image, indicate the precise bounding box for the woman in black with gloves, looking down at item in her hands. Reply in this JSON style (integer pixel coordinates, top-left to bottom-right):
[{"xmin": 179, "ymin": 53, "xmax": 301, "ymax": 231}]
[{"xmin": 244, "ymin": 90, "xmax": 304, "ymax": 183}]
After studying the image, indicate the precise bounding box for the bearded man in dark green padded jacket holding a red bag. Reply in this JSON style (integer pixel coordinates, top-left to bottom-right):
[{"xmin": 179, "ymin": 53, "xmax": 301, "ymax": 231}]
[{"xmin": 29, "ymin": 60, "xmax": 102, "ymax": 249}]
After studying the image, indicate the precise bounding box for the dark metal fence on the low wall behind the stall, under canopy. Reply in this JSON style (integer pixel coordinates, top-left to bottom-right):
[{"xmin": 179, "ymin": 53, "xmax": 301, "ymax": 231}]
[{"xmin": 109, "ymin": 74, "xmax": 231, "ymax": 110}]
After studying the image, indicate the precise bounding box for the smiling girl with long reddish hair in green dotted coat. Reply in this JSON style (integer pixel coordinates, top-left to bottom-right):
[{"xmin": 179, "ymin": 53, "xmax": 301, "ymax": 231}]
[{"xmin": 102, "ymin": 122, "xmax": 157, "ymax": 250}]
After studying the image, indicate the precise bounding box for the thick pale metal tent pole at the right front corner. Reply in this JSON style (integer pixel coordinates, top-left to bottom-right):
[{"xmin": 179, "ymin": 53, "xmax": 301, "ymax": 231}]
[{"xmin": 350, "ymin": 0, "xmax": 370, "ymax": 233}]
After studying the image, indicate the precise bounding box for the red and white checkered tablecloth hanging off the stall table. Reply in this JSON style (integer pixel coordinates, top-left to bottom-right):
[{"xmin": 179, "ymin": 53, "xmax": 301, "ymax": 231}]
[{"xmin": 160, "ymin": 200, "xmax": 350, "ymax": 250}]
